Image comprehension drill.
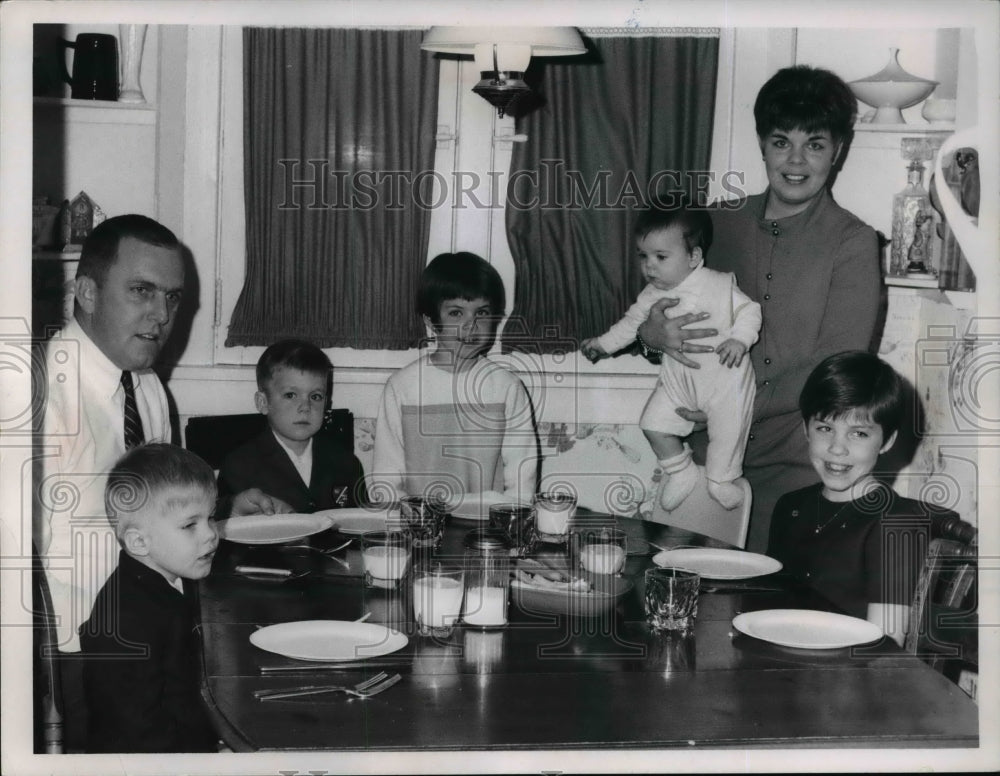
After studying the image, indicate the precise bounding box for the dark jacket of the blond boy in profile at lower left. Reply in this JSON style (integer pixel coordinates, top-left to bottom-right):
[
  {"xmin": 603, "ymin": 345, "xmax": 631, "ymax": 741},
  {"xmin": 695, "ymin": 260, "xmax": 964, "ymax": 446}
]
[{"xmin": 80, "ymin": 551, "xmax": 218, "ymax": 753}]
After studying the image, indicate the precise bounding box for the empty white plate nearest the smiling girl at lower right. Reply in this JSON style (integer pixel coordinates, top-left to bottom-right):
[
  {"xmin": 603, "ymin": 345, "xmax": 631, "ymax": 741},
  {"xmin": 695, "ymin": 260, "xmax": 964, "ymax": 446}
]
[{"xmin": 733, "ymin": 609, "xmax": 883, "ymax": 649}]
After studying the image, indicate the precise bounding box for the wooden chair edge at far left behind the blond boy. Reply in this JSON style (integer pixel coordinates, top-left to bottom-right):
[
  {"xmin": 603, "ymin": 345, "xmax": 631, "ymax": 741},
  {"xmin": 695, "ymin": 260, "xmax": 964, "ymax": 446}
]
[{"xmin": 31, "ymin": 544, "xmax": 65, "ymax": 754}]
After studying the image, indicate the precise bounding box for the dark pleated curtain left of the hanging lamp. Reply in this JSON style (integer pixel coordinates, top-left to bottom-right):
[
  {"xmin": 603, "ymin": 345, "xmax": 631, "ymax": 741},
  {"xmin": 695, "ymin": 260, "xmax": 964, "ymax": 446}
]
[{"xmin": 232, "ymin": 28, "xmax": 438, "ymax": 349}]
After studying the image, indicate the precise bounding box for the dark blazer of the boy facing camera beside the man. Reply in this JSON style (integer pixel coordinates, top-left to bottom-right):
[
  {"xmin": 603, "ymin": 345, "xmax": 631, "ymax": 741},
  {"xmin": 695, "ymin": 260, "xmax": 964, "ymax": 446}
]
[{"xmin": 219, "ymin": 428, "xmax": 368, "ymax": 514}]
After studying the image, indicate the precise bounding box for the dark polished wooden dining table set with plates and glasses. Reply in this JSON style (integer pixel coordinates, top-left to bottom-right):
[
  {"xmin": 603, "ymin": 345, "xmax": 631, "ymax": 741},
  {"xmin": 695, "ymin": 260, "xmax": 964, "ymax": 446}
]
[{"xmin": 200, "ymin": 516, "xmax": 979, "ymax": 752}]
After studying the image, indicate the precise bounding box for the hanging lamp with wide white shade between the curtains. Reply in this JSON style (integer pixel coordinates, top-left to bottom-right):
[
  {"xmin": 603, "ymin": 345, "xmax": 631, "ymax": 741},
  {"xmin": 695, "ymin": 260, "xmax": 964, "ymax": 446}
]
[{"xmin": 420, "ymin": 27, "xmax": 587, "ymax": 118}]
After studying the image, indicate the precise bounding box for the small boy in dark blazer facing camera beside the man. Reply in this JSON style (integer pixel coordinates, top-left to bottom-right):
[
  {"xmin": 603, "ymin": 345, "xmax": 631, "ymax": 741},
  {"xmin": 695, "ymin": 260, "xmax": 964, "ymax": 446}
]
[{"xmin": 219, "ymin": 340, "xmax": 368, "ymax": 513}]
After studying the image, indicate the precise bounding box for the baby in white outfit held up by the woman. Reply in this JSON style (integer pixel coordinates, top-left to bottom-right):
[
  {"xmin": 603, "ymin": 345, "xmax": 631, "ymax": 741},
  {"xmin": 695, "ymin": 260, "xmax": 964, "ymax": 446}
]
[{"xmin": 580, "ymin": 207, "xmax": 761, "ymax": 511}]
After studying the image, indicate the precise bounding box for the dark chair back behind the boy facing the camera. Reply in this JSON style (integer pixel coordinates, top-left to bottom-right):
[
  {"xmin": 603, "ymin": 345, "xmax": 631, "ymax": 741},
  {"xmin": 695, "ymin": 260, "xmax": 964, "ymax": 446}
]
[{"xmin": 184, "ymin": 408, "xmax": 354, "ymax": 471}]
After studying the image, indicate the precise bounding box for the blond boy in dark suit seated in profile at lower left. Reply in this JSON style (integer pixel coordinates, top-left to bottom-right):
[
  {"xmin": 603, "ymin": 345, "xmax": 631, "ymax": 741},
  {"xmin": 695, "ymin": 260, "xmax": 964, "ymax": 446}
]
[{"xmin": 80, "ymin": 443, "xmax": 219, "ymax": 753}]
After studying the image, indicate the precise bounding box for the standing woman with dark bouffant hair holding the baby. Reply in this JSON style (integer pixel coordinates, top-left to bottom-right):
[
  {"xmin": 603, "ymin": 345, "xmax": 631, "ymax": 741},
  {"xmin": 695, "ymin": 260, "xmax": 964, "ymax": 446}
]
[{"xmin": 639, "ymin": 65, "xmax": 880, "ymax": 551}]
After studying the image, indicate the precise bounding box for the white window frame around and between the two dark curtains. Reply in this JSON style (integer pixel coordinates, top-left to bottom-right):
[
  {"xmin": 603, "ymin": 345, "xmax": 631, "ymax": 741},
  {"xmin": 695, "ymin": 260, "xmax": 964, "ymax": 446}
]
[{"xmin": 212, "ymin": 26, "xmax": 734, "ymax": 388}]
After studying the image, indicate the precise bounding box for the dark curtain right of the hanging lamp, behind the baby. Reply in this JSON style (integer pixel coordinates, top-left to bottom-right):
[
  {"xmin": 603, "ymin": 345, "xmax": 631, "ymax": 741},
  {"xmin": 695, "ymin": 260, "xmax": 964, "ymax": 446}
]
[{"xmin": 503, "ymin": 37, "xmax": 719, "ymax": 353}]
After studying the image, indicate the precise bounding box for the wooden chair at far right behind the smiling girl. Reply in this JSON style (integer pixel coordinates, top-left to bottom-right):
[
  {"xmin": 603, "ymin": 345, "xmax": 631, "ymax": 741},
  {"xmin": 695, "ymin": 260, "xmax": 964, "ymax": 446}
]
[{"xmin": 904, "ymin": 516, "xmax": 979, "ymax": 697}]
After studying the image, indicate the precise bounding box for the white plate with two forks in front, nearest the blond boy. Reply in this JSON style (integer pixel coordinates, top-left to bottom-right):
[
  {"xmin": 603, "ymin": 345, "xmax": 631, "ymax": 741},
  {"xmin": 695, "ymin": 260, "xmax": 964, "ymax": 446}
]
[{"xmin": 250, "ymin": 620, "xmax": 409, "ymax": 660}]
